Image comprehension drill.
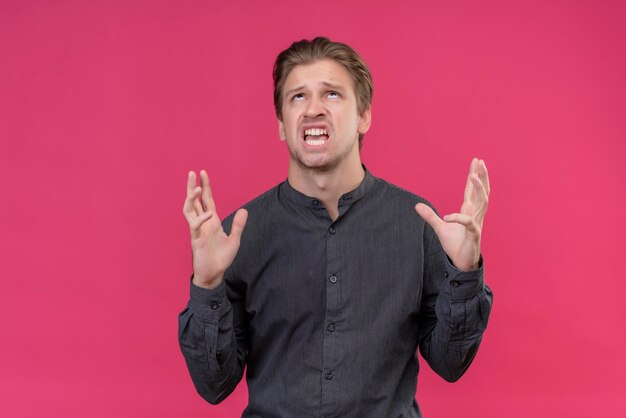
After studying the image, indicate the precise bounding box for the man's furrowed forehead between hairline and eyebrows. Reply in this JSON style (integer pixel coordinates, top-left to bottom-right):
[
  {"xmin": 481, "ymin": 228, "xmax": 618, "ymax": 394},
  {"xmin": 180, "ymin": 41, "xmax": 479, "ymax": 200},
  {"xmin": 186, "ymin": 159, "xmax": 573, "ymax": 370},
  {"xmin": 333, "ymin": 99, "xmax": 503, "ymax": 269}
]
[{"xmin": 283, "ymin": 59, "xmax": 353, "ymax": 92}]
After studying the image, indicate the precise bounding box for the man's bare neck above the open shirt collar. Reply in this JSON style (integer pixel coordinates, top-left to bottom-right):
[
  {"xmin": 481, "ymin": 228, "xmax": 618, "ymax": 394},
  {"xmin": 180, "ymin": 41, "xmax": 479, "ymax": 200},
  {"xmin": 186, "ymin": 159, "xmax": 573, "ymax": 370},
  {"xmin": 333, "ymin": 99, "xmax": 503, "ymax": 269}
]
[{"xmin": 288, "ymin": 157, "xmax": 365, "ymax": 220}]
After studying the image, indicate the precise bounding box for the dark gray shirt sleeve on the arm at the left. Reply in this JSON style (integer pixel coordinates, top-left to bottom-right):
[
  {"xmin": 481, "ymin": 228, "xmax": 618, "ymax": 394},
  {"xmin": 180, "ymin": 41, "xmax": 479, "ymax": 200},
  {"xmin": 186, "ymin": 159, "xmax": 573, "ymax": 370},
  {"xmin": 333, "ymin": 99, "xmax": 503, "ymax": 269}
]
[{"xmin": 178, "ymin": 280, "xmax": 247, "ymax": 404}]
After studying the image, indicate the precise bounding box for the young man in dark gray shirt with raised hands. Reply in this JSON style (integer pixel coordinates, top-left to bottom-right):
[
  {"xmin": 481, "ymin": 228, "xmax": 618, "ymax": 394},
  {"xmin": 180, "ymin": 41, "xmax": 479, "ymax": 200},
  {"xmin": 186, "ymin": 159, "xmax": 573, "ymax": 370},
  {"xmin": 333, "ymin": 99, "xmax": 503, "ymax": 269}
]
[{"xmin": 179, "ymin": 38, "xmax": 492, "ymax": 418}]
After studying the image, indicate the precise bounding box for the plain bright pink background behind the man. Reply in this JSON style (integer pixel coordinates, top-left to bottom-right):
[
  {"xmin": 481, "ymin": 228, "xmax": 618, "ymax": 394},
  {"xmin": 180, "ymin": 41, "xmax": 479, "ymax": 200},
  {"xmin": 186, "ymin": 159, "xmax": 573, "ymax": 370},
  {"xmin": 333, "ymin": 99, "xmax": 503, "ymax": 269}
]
[{"xmin": 0, "ymin": 0, "xmax": 626, "ymax": 418}]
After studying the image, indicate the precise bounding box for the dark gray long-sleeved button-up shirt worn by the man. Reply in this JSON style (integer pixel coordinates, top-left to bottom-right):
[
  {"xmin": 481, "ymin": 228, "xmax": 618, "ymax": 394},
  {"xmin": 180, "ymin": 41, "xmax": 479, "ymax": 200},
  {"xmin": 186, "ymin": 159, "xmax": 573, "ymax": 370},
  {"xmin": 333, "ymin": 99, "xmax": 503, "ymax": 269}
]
[{"xmin": 179, "ymin": 172, "xmax": 492, "ymax": 418}]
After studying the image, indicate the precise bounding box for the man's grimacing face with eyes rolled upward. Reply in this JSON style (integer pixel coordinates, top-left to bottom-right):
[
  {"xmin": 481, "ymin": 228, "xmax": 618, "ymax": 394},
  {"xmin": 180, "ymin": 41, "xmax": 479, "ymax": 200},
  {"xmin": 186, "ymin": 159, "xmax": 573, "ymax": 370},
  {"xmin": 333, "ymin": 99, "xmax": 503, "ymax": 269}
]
[{"xmin": 278, "ymin": 59, "xmax": 370, "ymax": 170}]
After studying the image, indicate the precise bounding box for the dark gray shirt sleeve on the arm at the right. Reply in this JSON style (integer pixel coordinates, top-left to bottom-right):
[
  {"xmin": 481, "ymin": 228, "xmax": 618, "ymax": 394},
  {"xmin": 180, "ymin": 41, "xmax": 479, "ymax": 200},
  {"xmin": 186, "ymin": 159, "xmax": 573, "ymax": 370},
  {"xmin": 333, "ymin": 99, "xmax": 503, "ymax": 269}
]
[{"xmin": 419, "ymin": 228, "xmax": 493, "ymax": 382}]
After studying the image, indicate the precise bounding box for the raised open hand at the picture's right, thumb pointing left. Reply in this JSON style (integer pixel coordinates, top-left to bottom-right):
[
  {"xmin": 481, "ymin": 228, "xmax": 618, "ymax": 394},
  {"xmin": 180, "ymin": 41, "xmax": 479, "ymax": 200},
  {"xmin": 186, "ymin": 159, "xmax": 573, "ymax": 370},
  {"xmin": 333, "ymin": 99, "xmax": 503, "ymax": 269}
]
[{"xmin": 415, "ymin": 158, "xmax": 489, "ymax": 271}]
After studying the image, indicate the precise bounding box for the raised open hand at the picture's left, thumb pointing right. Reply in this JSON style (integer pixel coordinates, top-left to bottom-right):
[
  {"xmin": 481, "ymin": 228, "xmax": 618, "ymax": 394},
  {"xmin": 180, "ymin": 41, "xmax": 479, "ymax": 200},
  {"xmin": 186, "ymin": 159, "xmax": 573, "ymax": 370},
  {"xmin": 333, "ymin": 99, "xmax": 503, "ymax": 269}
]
[{"xmin": 183, "ymin": 170, "xmax": 248, "ymax": 289}]
